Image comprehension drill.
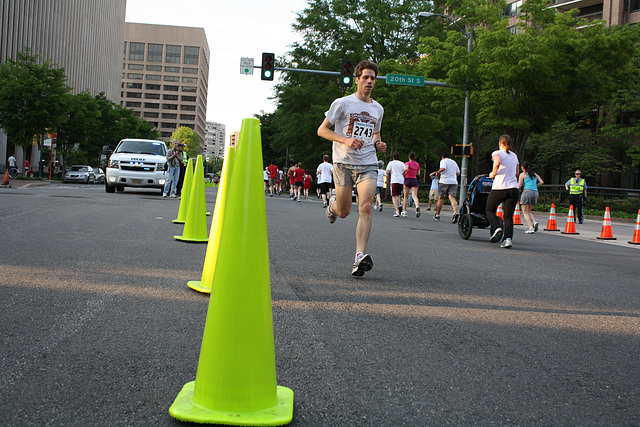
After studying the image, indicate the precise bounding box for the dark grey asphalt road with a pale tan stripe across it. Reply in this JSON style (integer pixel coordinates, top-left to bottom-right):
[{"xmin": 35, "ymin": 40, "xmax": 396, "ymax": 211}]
[{"xmin": 0, "ymin": 185, "xmax": 640, "ymax": 426}]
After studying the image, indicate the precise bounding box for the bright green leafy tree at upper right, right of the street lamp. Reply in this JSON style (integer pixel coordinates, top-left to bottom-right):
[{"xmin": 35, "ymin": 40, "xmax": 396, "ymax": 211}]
[{"xmin": 422, "ymin": 0, "xmax": 638, "ymax": 157}]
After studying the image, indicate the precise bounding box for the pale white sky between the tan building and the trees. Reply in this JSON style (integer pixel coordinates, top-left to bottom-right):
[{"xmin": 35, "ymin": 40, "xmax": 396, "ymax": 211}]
[{"xmin": 126, "ymin": 0, "xmax": 307, "ymax": 137}]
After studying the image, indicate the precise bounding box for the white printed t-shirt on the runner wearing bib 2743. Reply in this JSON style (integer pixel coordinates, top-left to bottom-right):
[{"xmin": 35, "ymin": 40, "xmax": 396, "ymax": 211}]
[{"xmin": 325, "ymin": 94, "xmax": 384, "ymax": 165}]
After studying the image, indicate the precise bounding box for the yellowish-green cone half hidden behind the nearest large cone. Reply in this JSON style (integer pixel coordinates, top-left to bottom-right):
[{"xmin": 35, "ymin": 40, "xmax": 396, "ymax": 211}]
[{"xmin": 187, "ymin": 147, "xmax": 236, "ymax": 294}]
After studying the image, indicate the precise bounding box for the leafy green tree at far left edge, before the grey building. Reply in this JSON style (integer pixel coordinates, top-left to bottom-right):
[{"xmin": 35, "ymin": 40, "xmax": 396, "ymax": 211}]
[{"xmin": 0, "ymin": 51, "xmax": 71, "ymax": 147}]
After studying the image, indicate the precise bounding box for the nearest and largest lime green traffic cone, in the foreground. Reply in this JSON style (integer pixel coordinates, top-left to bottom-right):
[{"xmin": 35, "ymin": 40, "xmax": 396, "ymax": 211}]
[{"xmin": 169, "ymin": 119, "xmax": 293, "ymax": 426}]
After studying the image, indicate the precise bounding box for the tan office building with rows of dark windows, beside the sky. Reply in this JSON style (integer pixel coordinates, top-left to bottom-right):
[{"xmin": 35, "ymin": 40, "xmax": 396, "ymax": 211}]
[{"xmin": 121, "ymin": 22, "xmax": 209, "ymax": 146}]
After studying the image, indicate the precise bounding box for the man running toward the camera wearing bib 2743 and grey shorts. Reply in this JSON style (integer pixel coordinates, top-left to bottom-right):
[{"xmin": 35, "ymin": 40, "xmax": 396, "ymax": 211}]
[{"xmin": 318, "ymin": 61, "xmax": 387, "ymax": 276}]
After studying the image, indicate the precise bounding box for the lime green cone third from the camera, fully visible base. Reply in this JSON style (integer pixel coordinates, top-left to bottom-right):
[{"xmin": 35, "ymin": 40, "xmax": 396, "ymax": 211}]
[{"xmin": 173, "ymin": 156, "xmax": 209, "ymax": 242}]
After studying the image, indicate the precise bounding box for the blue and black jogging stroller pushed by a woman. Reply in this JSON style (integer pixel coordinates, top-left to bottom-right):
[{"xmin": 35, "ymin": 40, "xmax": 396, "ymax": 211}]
[{"xmin": 458, "ymin": 175, "xmax": 504, "ymax": 240}]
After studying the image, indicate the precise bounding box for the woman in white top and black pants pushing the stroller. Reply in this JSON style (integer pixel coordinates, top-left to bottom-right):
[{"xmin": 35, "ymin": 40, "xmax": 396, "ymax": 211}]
[{"xmin": 487, "ymin": 135, "xmax": 519, "ymax": 248}]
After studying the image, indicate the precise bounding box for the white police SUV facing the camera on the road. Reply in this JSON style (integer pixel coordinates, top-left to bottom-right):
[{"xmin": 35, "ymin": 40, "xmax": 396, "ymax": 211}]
[{"xmin": 105, "ymin": 139, "xmax": 167, "ymax": 193}]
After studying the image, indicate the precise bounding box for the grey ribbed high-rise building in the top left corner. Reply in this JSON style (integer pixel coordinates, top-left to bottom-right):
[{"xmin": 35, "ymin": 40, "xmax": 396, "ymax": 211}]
[{"xmin": 0, "ymin": 0, "xmax": 126, "ymax": 171}]
